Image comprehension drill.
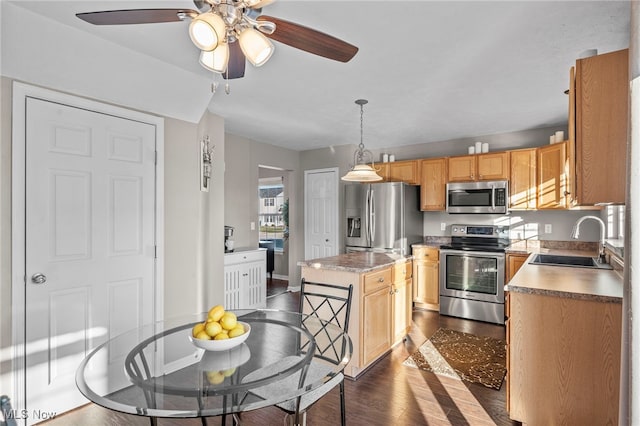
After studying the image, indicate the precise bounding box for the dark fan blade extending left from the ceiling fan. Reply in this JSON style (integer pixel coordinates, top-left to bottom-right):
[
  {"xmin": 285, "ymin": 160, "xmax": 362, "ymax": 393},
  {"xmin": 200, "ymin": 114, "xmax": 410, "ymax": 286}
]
[{"xmin": 76, "ymin": 9, "xmax": 199, "ymax": 25}]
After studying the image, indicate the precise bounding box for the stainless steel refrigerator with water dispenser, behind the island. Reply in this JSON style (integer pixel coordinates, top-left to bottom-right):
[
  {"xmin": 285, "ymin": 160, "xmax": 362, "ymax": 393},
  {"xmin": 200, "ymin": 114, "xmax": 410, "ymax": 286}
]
[{"xmin": 344, "ymin": 182, "xmax": 423, "ymax": 255}]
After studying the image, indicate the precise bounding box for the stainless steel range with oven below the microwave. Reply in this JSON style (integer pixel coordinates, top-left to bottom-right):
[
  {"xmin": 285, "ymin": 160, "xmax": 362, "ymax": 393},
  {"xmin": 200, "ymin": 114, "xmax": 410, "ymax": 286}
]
[{"xmin": 440, "ymin": 225, "xmax": 509, "ymax": 324}]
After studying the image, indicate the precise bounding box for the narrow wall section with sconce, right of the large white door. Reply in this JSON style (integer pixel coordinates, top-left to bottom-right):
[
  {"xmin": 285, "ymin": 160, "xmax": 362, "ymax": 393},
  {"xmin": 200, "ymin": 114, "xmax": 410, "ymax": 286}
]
[{"xmin": 165, "ymin": 113, "xmax": 225, "ymax": 317}]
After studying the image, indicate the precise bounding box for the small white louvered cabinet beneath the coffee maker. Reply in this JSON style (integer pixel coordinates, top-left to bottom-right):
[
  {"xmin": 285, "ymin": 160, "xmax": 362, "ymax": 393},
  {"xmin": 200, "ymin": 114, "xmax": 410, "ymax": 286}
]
[{"xmin": 224, "ymin": 249, "xmax": 267, "ymax": 309}]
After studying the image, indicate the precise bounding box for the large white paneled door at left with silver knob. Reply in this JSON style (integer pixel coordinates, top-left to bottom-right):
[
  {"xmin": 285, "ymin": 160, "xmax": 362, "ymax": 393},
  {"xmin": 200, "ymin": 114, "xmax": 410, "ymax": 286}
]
[{"xmin": 25, "ymin": 98, "xmax": 156, "ymax": 413}]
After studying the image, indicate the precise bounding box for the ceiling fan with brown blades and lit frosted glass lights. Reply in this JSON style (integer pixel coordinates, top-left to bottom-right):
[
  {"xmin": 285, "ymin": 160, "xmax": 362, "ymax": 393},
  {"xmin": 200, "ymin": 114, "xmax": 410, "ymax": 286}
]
[{"xmin": 76, "ymin": 0, "xmax": 358, "ymax": 79}]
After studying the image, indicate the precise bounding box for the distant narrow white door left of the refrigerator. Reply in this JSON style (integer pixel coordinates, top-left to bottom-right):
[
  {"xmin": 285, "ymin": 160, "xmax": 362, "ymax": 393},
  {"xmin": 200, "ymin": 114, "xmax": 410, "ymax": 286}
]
[{"xmin": 304, "ymin": 168, "xmax": 338, "ymax": 259}]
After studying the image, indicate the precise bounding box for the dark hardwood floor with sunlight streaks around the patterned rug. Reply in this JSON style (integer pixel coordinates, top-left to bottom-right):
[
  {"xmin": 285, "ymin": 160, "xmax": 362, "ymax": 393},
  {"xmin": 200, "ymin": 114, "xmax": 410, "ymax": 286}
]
[{"xmin": 43, "ymin": 292, "xmax": 519, "ymax": 426}]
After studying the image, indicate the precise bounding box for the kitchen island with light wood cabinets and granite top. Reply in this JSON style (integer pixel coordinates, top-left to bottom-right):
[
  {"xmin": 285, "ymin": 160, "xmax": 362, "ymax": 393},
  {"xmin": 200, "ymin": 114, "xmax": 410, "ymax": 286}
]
[{"xmin": 298, "ymin": 252, "xmax": 412, "ymax": 379}]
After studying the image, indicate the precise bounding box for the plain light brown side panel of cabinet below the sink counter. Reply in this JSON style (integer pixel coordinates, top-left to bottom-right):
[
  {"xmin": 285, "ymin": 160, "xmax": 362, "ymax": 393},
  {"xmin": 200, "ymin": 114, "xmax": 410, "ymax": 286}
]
[{"xmin": 507, "ymin": 291, "xmax": 622, "ymax": 425}]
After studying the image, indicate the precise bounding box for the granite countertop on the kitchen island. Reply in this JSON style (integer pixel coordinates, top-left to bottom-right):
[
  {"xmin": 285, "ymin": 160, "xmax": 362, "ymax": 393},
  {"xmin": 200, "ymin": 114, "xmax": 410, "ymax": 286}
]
[{"xmin": 298, "ymin": 252, "xmax": 412, "ymax": 273}]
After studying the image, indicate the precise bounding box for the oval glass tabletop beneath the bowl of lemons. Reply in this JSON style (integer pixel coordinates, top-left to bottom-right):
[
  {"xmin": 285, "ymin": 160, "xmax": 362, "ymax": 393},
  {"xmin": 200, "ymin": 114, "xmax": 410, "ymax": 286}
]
[{"xmin": 76, "ymin": 309, "xmax": 352, "ymax": 417}]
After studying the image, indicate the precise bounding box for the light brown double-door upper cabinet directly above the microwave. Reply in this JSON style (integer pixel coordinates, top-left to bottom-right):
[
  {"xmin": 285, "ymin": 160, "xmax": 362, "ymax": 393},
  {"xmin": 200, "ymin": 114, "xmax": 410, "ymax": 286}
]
[{"xmin": 448, "ymin": 152, "xmax": 509, "ymax": 182}]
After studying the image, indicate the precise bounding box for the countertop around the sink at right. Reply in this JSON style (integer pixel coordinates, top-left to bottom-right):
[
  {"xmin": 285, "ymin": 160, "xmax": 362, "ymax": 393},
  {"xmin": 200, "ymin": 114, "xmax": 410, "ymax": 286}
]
[{"xmin": 505, "ymin": 249, "xmax": 623, "ymax": 303}]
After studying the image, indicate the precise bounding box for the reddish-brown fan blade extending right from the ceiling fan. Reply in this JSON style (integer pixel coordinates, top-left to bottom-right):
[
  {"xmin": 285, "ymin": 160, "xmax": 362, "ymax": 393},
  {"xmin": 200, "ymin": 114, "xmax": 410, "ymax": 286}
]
[{"xmin": 257, "ymin": 15, "xmax": 358, "ymax": 62}]
